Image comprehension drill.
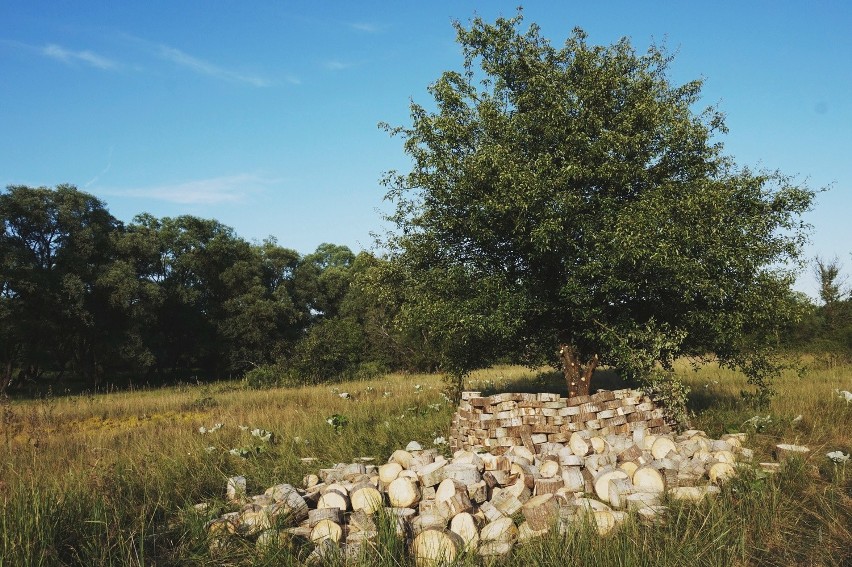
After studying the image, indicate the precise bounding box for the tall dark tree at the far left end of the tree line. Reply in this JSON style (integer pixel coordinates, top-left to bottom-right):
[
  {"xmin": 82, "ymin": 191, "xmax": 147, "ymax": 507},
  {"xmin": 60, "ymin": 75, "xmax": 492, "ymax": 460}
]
[{"xmin": 0, "ymin": 185, "xmax": 120, "ymax": 392}]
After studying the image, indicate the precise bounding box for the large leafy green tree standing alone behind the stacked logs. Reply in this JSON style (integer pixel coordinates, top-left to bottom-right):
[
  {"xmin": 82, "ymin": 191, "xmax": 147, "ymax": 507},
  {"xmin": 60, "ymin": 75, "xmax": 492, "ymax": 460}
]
[{"xmin": 385, "ymin": 13, "xmax": 814, "ymax": 406}]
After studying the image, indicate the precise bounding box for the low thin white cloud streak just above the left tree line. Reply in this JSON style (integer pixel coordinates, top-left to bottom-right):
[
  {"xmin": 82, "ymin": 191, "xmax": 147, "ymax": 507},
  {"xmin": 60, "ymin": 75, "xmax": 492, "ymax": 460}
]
[{"xmin": 100, "ymin": 173, "xmax": 278, "ymax": 205}]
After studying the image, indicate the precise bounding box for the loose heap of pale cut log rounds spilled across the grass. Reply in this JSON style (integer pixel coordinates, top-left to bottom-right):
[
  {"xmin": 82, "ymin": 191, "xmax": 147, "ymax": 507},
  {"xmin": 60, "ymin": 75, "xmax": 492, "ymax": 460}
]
[{"xmin": 207, "ymin": 426, "xmax": 751, "ymax": 566}]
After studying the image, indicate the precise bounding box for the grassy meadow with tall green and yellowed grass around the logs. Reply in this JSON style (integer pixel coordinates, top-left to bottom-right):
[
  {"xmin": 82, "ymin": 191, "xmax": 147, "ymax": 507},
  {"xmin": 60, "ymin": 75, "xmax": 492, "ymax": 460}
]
[{"xmin": 0, "ymin": 364, "xmax": 852, "ymax": 567}]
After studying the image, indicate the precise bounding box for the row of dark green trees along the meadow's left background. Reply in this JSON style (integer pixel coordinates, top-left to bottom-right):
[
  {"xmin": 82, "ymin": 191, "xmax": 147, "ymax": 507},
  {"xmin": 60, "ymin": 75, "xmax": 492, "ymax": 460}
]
[{"xmin": 0, "ymin": 185, "xmax": 434, "ymax": 392}]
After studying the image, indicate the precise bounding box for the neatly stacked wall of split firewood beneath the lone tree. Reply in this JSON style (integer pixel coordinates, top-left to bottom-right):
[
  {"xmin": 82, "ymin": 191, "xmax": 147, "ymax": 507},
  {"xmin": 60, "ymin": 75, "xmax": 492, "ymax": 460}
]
[{"xmin": 449, "ymin": 389, "xmax": 673, "ymax": 454}]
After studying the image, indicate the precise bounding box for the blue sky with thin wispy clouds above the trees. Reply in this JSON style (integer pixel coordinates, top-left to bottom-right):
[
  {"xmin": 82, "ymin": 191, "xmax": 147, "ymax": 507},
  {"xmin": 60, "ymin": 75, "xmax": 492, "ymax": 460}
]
[{"xmin": 0, "ymin": 0, "xmax": 852, "ymax": 296}]
